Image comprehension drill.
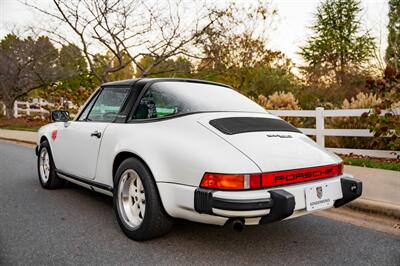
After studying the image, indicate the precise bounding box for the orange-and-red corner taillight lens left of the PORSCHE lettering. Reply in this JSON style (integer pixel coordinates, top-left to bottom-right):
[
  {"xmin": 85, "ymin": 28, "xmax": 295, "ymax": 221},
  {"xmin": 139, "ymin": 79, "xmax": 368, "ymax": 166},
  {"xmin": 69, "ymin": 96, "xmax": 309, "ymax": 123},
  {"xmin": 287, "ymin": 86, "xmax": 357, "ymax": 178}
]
[{"xmin": 200, "ymin": 173, "xmax": 261, "ymax": 190}]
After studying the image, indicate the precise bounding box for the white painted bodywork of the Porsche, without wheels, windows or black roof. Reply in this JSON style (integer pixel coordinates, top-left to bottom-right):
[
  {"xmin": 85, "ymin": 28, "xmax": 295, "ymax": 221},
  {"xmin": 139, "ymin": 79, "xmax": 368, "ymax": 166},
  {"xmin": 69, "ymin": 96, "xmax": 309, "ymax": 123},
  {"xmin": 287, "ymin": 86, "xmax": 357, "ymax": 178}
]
[{"xmin": 37, "ymin": 79, "xmax": 361, "ymax": 231}]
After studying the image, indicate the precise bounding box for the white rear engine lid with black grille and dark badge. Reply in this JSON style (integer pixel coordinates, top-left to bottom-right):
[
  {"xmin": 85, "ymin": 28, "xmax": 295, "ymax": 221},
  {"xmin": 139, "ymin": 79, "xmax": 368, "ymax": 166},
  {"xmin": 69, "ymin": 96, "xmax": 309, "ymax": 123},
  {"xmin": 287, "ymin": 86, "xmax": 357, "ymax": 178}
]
[{"xmin": 198, "ymin": 113, "xmax": 341, "ymax": 172}]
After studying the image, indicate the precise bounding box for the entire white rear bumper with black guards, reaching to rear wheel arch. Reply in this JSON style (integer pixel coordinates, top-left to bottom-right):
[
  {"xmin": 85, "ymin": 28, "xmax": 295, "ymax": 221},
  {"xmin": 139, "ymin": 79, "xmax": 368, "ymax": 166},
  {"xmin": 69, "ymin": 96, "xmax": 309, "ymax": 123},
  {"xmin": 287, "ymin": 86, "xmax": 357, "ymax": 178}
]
[{"xmin": 157, "ymin": 174, "xmax": 362, "ymax": 225}]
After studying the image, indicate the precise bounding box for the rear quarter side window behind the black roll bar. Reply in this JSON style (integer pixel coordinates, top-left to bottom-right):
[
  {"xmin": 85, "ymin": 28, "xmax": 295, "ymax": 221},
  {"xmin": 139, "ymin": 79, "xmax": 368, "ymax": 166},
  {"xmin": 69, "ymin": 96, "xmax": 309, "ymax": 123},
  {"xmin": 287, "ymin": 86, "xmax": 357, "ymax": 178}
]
[{"xmin": 133, "ymin": 88, "xmax": 180, "ymax": 119}]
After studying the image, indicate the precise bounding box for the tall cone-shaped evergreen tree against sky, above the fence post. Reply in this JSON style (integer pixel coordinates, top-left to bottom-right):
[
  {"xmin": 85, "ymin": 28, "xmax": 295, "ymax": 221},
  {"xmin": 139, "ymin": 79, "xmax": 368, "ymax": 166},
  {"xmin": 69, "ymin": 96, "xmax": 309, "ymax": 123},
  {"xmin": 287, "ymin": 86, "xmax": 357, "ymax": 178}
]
[{"xmin": 300, "ymin": 0, "xmax": 375, "ymax": 85}]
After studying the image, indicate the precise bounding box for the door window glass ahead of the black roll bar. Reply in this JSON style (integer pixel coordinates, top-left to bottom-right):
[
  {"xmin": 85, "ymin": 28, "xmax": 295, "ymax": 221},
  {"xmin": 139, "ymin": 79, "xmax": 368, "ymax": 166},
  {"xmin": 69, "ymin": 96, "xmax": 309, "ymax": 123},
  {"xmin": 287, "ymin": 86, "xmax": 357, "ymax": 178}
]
[{"xmin": 87, "ymin": 88, "xmax": 129, "ymax": 122}]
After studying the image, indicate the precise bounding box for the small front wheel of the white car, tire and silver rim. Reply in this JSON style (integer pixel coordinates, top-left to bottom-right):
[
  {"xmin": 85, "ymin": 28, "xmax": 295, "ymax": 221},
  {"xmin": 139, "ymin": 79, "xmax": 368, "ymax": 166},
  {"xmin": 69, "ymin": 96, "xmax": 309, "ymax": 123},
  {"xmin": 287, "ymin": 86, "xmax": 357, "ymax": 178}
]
[{"xmin": 37, "ymin": 140, "xmax": 65, "ymax": 189}]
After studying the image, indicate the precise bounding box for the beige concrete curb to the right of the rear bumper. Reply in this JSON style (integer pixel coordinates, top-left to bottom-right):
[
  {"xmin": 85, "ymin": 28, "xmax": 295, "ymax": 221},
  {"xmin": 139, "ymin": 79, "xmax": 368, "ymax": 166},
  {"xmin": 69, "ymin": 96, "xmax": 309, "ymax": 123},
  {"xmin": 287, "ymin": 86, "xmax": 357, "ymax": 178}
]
[{"xmin": 344, "ymin": 199, "xmax": 400, "ymax": 220}]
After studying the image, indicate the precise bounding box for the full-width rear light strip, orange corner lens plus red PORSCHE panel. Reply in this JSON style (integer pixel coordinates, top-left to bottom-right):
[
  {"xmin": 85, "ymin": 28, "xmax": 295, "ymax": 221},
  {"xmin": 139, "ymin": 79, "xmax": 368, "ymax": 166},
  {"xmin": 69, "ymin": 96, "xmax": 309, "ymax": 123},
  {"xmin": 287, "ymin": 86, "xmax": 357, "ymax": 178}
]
[{"xmin": 200, "ymin": 164, "xmax": 343, "ymax": 190}]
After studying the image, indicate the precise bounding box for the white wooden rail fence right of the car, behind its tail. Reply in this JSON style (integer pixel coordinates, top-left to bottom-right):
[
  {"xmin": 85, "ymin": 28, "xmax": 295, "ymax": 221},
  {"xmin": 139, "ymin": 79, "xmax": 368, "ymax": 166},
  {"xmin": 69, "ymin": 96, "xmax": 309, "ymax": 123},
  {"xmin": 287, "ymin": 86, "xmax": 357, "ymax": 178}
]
[{"xmin": 268, "ymin": 107, "xmax": 400, "ymax": 158}]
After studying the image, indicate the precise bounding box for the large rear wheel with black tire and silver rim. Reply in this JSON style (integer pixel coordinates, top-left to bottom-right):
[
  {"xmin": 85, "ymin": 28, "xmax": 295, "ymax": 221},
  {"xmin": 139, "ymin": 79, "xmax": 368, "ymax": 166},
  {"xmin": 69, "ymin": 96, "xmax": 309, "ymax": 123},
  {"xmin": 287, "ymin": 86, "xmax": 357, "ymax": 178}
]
[{"xmin": 113, "ymin": 158, "xmax": 173, "ymax": 241}]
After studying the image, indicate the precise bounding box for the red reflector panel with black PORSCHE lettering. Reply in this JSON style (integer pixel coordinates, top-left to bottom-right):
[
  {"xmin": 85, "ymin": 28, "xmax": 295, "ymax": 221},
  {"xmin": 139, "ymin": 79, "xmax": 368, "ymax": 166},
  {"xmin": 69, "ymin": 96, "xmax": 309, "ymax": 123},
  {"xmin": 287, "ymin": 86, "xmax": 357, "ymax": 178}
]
[{"xmin": 261, "ymin": 164, "xmax": 343, "ymax": 187}]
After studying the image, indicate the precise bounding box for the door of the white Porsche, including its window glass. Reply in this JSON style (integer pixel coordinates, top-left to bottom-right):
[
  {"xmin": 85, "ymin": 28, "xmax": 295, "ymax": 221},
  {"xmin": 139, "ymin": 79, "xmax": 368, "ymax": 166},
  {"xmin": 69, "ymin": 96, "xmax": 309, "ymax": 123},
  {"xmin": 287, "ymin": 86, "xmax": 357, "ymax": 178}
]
[{"xmin": 53, "ymin": 87, "xmax": 130, "ymax": 179}]
